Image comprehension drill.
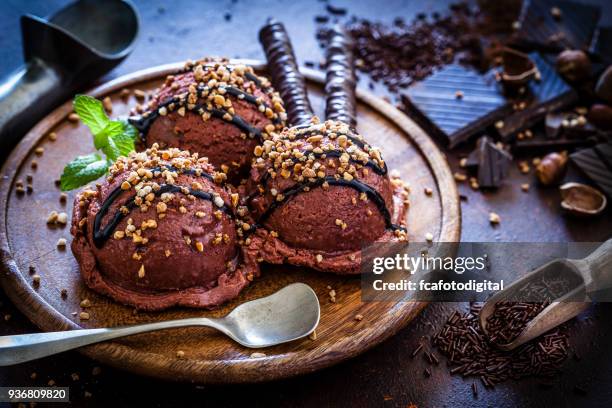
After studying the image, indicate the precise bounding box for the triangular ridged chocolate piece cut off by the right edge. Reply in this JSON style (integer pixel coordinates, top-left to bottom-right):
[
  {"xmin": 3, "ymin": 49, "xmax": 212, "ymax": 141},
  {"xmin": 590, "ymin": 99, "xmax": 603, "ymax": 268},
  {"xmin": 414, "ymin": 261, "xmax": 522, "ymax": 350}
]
[{"xmin": 570, "ymin": 143, "xmax": 612, "ymax": 198}]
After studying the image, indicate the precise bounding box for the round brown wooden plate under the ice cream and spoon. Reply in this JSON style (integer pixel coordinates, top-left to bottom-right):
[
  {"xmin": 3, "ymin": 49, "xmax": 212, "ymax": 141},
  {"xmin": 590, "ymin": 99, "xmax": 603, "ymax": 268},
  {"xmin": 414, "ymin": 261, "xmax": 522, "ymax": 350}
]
[{"xmin": 0, "ymin": 61, "xmax": 461, "ymax": 383}]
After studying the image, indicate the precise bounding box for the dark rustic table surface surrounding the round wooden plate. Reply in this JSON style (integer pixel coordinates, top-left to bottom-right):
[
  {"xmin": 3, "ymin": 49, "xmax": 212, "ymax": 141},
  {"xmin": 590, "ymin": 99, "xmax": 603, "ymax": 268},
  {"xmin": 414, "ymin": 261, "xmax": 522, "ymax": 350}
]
[{"xmin": 0, "ymin": 0, "xmax": 612, "ymax": 407}]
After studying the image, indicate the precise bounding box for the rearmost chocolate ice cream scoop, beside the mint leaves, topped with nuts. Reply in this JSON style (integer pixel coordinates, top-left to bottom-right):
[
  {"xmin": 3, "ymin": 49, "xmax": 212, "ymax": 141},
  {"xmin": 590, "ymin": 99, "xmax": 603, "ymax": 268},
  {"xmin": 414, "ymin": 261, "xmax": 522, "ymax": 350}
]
[{"xmin": 131, "ymin": 59, "xmax": 286, "ymax": 181}]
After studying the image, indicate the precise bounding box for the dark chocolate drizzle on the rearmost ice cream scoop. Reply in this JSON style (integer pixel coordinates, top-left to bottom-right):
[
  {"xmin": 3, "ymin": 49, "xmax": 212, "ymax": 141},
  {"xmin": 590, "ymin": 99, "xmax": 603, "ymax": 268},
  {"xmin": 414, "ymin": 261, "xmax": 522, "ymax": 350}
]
[{"xmin": 128, "ymin": 72, "xmax": 281, "ymax": 143}]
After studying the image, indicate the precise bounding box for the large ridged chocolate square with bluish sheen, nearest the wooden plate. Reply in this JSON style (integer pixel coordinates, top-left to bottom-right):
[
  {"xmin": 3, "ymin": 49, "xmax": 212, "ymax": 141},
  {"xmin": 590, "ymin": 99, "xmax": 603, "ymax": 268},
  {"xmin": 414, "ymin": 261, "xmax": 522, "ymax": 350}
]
[{"xmin": 402, "ymin": 64, "xmax": 512, "ymax": 148}]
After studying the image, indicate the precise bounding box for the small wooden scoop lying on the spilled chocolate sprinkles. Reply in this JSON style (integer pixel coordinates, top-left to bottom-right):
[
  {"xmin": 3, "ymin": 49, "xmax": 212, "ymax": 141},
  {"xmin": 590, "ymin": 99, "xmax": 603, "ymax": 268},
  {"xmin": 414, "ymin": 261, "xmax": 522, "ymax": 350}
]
[{"xmin": 479, "ymin": 239, "xmax": 612, "ymax": 351}]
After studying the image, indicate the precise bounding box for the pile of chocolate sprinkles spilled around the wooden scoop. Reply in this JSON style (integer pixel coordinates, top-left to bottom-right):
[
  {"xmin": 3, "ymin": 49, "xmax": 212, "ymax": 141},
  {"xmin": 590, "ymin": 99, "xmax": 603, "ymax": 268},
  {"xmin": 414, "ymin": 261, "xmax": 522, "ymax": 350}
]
[{"xmin": 432, "ymin": 304, "xmax": 569, "ymax": 393}]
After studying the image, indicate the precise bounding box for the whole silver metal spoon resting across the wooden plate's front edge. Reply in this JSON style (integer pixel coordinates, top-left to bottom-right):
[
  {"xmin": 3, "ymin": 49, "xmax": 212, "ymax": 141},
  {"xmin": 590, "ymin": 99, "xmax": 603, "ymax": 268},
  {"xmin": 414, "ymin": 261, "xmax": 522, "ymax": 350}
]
[{"xmin": 0, "ymin": 283, "xmax": 320, "ymax": 366}]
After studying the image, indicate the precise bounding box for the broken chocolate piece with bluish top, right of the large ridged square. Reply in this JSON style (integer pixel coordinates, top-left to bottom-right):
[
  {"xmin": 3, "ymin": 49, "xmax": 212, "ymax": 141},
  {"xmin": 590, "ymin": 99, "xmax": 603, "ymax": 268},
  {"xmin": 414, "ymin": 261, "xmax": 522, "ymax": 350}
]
[{"xmin": 497, "ymin": 53, "xmax": 578, "ymax": 141}]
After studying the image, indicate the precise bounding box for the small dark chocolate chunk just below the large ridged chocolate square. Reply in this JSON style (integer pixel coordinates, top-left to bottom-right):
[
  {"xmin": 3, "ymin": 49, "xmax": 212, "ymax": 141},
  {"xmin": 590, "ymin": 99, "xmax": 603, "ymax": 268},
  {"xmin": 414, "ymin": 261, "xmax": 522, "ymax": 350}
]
[{"xmin": 466, "ymin": 136, "xmax": 512, "ymax": 188}]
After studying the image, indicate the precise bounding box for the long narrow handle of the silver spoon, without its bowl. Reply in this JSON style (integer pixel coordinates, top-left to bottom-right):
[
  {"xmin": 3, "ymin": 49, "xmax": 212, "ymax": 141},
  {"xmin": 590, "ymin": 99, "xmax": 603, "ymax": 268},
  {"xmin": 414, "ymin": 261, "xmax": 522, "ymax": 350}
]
[{"xmin": 0, "ymin": 318, "xmax": 222, "ymax": 367}]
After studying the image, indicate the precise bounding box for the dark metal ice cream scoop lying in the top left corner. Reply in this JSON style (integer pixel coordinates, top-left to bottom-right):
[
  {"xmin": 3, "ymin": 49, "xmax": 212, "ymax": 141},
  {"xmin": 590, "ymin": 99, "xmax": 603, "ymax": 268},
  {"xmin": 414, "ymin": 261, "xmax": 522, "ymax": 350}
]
[{"xmin": 0, "ymin": 0, "xmax": 138, "ymax": 152}]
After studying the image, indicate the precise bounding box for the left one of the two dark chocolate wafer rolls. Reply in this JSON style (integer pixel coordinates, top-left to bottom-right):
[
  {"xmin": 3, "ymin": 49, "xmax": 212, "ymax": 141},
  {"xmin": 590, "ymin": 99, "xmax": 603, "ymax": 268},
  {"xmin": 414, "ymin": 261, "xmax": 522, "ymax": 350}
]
[{"xmin": 259, "ymin": 19, "xmax": 314, "ymax": 125}]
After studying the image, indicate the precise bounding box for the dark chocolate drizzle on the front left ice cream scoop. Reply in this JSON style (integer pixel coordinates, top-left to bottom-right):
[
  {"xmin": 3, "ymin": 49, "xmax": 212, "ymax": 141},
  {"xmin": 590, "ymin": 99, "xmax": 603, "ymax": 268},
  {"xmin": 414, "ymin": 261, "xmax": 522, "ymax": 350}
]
[{"xmin": 93, "ymin": 167, "xmax": 233, "ymax": 248}]
